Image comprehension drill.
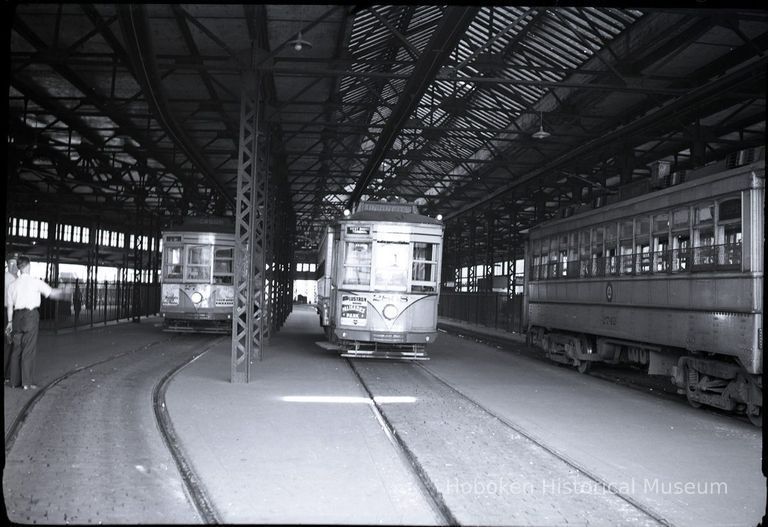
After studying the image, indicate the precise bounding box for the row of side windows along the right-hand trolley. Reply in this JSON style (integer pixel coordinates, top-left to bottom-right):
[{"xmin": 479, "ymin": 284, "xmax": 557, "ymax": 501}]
[{"xmin": 531, "ymin": 195, "xmax": 742, "ymax": 280}]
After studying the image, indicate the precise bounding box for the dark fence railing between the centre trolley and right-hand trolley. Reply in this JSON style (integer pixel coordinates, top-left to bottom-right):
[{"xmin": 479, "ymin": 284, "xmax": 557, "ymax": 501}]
[{"xmin": 437, "ymin": 292, "xmax": 524, "ymax": 333}]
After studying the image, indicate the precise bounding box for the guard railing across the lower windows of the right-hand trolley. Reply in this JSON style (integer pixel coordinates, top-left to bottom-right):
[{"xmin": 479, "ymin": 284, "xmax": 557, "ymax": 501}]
[{"xmin": 531, "ymin": 243, "xmax": 741, "ymax": 280}]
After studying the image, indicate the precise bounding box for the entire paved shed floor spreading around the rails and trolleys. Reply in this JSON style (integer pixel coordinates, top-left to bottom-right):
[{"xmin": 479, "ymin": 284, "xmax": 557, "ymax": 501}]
[{"xmin": 3, "ymin": 306, "xmax": 765, "ymax": 526}]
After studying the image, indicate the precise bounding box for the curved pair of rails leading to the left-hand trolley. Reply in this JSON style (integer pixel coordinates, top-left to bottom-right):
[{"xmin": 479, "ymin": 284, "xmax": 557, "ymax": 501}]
[{"xmin": 5, "ymin": 334, "xmax": 224, "ymax": 524}]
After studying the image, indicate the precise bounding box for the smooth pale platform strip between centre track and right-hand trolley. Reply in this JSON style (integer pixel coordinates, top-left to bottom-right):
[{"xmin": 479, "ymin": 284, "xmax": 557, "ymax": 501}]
[{"xmin": 427, "ymin": 326, "xmax": 766, "ymax": 526}]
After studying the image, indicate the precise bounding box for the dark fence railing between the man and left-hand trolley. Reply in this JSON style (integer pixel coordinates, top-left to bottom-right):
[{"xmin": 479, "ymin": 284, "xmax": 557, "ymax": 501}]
[{"xmin": 40, "ymin": 280, "xmax": 160, "ymax": 331}]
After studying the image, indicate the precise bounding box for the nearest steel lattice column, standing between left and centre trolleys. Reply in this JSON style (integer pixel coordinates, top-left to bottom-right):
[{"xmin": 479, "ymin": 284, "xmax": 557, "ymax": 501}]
[{"xmin": 231, "ymin": 72, "xmax": 267, "ymax": 382}]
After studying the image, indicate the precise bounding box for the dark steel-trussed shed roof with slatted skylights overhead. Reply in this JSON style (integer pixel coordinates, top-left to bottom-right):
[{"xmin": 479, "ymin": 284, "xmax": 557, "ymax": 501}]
[{"xmin": 6, "ymin": 3, "xmax": 768, "ymax": 261}]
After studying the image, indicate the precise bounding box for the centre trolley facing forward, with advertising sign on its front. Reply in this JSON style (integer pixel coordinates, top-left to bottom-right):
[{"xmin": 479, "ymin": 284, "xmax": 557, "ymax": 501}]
[{"xmin": 317, "ymin": 201, "xmax": 443, "ymax": 360}]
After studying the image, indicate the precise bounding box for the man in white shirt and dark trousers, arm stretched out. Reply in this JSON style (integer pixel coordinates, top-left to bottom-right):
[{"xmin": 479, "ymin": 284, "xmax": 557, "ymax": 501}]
[{"xmin": 5, "ymin": 256, "xmax": 70, "ymax": 390}]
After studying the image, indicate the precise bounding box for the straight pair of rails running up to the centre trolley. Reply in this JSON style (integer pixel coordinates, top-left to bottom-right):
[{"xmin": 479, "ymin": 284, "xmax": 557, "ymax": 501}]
[{"xmin": 346, "ymin": 359, "xmax": 672, "ymax": 527}]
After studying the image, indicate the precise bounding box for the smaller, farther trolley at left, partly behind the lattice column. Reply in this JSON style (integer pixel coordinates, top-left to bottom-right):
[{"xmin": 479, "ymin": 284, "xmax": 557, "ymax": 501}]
[{"xmin": 160, "ymin": 217, "xmax": 235, "ymax": 333}]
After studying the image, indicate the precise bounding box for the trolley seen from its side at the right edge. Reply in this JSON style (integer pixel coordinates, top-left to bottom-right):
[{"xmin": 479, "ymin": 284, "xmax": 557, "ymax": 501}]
[{"xmin": 525, "ymin": 150, "xmax": 765, "ymax": 425}]
